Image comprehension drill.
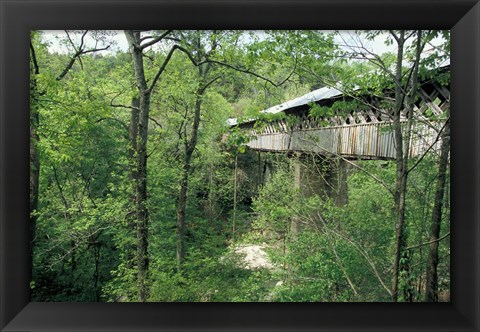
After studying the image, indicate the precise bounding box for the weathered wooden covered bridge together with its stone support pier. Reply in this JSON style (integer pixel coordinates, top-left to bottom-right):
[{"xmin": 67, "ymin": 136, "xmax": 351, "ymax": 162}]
[{"xmin": 229, "ymin": 66, "xmax": 450, "ymax": 236}]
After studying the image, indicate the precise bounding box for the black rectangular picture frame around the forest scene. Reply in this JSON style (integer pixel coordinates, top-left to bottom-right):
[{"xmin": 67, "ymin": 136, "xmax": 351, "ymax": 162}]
[{"xmin": 0, "ymin": 0, "xmax": 480, "ymax": 331}]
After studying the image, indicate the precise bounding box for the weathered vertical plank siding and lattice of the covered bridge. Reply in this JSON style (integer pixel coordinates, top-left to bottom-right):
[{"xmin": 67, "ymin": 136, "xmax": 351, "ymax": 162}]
[{"xmin": 239, "ymin": 73, "xmax": 450, "ymax": 159}]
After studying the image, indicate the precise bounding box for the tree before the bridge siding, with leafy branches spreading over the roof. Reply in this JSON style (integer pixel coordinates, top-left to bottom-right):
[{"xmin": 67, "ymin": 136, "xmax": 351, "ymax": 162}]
[{"xmin": 251, "ymin": 30, "xmax": 449, "ymax": 301}]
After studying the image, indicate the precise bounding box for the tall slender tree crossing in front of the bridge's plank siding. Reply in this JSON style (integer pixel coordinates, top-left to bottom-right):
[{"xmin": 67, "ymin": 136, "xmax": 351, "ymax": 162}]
[{"xmin": 330, "ymin": 30, "xmax": 446, "ymax": 302}]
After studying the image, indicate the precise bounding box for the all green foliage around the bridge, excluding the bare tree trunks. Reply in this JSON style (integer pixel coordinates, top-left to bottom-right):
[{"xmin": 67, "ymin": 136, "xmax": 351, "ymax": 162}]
[{"xmin": 30, "ymin": 31, "xmax": 450, "ymax": 302}]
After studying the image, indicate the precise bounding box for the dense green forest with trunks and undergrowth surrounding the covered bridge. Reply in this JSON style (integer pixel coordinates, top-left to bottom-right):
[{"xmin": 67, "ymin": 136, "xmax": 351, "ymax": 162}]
[{"xmin": 30, "ymin": 30, "xmax": 450, "ymax": 302}]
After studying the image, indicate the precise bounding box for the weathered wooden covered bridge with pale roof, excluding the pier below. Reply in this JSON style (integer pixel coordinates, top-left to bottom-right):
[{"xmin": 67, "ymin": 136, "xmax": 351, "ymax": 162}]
[{"xmin": 229, "ymin": 65, "xmax": 450, "ymax": 159}]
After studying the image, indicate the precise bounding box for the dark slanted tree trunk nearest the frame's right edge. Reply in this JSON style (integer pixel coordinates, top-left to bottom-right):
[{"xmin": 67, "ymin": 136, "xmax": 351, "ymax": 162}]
[{"xmin": 425, "ymin": 113, "xmax": 450, "ymax": 302}]
